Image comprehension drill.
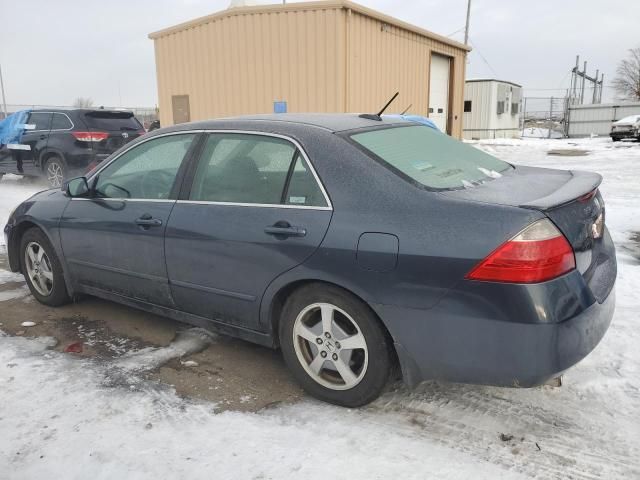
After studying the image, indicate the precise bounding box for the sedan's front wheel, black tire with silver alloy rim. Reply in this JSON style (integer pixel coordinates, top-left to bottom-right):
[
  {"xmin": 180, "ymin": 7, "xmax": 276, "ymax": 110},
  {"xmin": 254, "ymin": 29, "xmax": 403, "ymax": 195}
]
[{"xmin": 20, "ymin": 227, "xmax": 71, "ymax": 307}]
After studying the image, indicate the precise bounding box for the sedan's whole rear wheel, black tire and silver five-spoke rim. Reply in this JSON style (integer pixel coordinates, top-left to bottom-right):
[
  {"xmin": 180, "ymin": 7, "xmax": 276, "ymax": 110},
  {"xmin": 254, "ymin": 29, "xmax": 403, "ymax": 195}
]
[{"xmin": 279, "ymin": 284, "xmax": 393, "ymax": 408}]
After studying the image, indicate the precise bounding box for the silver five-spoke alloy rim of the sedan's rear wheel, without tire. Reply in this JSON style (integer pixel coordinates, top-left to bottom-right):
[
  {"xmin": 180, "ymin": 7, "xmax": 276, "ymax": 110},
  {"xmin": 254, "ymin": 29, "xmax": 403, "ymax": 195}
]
[{"xmin": 293, "ymin": 303, "xmax": 369, "ymax": 390}]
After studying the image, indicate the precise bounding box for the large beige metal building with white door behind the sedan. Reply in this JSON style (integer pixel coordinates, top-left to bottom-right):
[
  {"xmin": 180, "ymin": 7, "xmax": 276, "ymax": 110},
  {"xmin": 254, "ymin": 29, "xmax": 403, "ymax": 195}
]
[{"xmin": 149, "ymin": 0, "xmax": 469, "ymax": 137}]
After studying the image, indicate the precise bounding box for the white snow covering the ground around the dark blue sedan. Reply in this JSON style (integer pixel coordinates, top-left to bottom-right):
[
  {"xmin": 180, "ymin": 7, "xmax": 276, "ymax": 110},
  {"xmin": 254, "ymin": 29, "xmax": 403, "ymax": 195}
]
[{"xmin": 0, "ymin": 139, "xmax": 640, "ymax": 479}]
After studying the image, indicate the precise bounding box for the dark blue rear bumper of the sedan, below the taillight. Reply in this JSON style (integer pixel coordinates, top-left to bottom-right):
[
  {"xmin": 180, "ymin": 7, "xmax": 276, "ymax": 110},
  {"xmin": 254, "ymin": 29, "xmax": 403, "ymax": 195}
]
[{"xmin": 379, "ymin": 290, "xmax": 615, "ymax": 387}]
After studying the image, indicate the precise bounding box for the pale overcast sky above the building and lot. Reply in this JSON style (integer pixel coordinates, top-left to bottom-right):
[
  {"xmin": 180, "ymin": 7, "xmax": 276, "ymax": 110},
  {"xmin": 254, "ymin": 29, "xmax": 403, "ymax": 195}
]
[{"xmin": 0, "ymin": 0, "xmax": 640, "ymax": 107}]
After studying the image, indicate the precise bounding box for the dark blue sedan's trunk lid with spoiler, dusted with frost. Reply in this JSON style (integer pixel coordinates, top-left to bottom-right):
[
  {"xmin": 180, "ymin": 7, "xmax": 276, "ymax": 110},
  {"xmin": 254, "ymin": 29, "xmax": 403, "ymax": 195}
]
[{"xmin": 442, "ymin": 166, "xmax": 615, "ymax": 300}]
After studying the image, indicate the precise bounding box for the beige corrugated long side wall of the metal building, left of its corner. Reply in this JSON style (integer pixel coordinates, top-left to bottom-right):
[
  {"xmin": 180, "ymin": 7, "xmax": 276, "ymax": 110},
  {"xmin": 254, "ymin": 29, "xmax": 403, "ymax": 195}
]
[{"xmin": 154, "ymin": 8, "xmax": 345, "ymax": 125}]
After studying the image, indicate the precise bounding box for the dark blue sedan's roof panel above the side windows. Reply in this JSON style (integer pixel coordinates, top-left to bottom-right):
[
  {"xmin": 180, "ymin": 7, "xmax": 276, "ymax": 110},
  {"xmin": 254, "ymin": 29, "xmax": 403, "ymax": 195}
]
[{"xmin": 170, "ymin": 113, "xmax": 408, "ymax": 132}]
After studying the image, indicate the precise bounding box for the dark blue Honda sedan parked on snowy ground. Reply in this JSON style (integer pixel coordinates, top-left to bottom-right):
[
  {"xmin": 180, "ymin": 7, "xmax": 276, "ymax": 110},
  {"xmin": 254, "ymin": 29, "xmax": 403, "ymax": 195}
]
[{"xmin": 4, "ymin": 114, "xmax": 616, "ymax": 407}]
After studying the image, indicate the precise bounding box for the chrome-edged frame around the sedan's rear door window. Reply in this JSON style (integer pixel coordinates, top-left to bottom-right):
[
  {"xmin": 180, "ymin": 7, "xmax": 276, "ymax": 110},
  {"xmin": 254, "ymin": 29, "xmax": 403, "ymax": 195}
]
[{"xmin": 178, "ymin": 129, "xmax": 333, "ymax": 210}]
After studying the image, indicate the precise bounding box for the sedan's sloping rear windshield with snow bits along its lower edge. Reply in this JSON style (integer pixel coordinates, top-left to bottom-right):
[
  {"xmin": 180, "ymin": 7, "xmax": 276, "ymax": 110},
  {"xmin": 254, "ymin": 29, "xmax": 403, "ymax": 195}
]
[{"xmin": 350, "ymin": 125, "xmax": 511, "ymax": 190}]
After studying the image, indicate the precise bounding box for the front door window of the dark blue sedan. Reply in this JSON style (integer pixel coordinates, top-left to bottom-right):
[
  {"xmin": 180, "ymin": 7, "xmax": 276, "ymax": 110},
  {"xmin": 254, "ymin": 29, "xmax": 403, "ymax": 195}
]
[{"xmin": 94, "ymin": 133, "xmax": 195, "ymax": 200}]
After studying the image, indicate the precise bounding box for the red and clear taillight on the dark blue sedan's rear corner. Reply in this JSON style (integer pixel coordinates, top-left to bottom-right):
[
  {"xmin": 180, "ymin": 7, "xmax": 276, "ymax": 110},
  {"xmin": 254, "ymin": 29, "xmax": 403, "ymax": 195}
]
[{"xmin": 466, "ymin": 219, "xmax": 576, "ymax": 283}]
